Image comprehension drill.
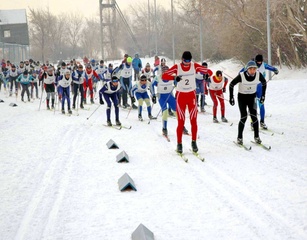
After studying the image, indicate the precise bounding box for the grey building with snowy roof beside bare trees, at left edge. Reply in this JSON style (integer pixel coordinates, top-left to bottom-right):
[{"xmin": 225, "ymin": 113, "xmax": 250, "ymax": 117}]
[{"xmin": 0, "ymin": 9, "xmax": 30, "ymax": 63}]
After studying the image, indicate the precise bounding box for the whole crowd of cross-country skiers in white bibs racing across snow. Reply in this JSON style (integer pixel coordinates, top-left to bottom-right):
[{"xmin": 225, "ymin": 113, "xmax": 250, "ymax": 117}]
[{"xmin": 0, "ymin": 51, "xmax": 278, "ymax": 153}]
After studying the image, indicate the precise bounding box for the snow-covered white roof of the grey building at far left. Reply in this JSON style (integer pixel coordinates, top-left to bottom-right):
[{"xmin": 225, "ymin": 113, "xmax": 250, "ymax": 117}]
[{"xmin": 0, "ymin": 9, "xmax": 27, "ymax": 25}]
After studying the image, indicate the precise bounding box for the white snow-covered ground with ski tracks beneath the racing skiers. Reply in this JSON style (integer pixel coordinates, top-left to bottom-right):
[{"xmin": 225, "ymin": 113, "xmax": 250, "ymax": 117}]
[{"xmin": 0, "ymin": 59, "xmax": 307, "ymax": 240}]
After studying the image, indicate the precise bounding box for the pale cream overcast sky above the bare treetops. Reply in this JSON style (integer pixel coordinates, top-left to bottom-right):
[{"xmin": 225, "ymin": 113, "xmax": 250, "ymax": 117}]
[{"xmin": 0, "ymin": 0, "xmax": 171, "ymax": 16}]
